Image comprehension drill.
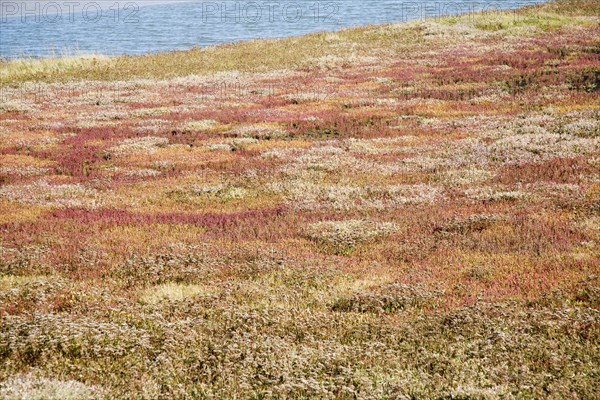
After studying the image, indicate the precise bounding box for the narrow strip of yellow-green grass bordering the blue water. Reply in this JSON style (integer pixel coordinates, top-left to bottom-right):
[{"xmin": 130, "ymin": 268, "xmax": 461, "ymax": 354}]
[{"xmin": 0, "ymin": 0, "xmax": 597, "ymax": 85}]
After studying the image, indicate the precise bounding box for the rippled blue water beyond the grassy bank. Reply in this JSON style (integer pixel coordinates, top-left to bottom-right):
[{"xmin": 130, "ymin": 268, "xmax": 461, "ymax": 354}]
[{"xmin": 0, "ymin": 0, "xmax": 541, "ymax": 59}]
